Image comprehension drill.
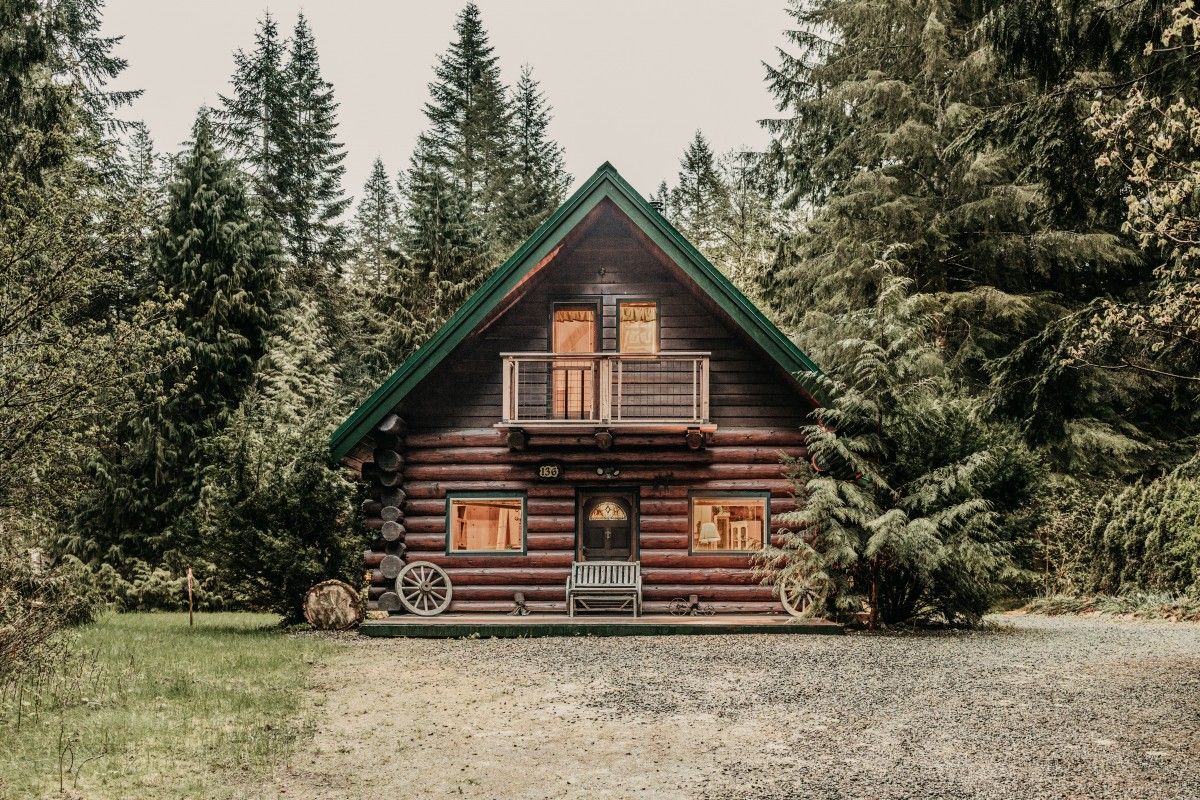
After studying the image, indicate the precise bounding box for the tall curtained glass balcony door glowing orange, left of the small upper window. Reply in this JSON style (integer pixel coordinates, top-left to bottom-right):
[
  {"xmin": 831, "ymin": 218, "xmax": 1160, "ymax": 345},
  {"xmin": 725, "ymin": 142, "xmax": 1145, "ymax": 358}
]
[{"xmin": 551, "ymin": 306, "xmax": 598, "ymax": 420}]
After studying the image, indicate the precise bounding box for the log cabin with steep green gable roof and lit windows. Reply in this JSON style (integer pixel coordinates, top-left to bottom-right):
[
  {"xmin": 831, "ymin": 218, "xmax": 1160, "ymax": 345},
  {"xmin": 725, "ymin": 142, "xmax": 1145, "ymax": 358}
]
[{"xmin": 330, "ymin": 163, "xmax": 817, "ymax": 614}]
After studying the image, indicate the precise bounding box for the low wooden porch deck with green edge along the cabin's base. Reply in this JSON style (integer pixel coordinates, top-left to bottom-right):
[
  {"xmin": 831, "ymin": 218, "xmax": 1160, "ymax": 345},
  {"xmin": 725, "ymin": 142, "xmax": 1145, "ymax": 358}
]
[{"xmin": 359, "ymin": 614, "xmax": 846, "ymax": 639}]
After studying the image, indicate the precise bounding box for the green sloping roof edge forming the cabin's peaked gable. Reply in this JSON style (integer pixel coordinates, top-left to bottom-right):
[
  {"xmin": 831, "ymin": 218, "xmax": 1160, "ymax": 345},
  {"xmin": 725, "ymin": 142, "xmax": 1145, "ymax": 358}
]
[{"xmin": 329, "ymin": 161, "xmax": 821, "ymax": 459}]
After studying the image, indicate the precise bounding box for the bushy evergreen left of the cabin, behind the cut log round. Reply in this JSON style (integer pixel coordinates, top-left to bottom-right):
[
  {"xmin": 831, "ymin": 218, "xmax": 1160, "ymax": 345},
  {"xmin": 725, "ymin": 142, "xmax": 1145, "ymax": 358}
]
[{"xmin": 199, "ymin": 301, "xmax": 362, "ymax": 621}]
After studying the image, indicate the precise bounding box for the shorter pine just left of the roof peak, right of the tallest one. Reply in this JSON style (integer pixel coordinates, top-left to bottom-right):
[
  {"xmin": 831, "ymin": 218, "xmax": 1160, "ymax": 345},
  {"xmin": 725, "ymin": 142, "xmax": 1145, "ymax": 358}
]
[{"xmin": 505, "ymin": 65, "xmax": 570, "ymax": 243}]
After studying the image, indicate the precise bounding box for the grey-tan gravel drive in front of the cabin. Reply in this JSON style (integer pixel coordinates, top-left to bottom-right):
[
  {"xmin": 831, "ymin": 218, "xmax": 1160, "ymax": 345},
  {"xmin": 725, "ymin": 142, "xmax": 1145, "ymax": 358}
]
[{"xmin": 247, "ymin": 615, "xmax": 1200, "ymax": 800}]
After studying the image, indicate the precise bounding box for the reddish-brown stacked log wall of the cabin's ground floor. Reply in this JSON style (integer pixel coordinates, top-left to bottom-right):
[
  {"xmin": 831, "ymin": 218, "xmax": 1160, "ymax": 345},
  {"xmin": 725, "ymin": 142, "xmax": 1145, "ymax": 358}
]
[{"xmin": 367, "ymin": 428, "xmax": 804, "ymax": 613}]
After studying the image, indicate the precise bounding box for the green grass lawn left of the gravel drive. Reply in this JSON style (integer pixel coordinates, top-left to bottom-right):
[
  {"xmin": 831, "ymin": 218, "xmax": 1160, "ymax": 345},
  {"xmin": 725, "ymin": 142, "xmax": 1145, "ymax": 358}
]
[{"xmin": 0, "ymin": 613, "xmax": 340, "ymax": 800}]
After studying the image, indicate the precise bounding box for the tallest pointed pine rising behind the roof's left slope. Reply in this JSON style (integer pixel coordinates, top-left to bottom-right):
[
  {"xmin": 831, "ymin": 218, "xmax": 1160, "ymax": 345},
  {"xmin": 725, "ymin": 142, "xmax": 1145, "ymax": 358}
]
[{"xmin": 420, "ymin": 2, "xmax": 516, "ymax": 258}]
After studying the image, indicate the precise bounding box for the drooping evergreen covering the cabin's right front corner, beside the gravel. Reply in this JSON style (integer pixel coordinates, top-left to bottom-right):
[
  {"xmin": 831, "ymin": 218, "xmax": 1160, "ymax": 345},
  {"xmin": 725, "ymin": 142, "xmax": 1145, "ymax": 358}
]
[{"xmin": 760, "ymin": 270, "xmax": 1040, "ymax": 625}]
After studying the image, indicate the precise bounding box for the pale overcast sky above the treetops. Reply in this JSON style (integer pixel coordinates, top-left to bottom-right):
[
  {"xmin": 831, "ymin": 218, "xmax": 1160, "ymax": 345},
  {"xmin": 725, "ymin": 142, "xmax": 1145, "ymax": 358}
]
[{"xmin": 104, "ymin": 0, "xmax": 790, "ymax": 196}]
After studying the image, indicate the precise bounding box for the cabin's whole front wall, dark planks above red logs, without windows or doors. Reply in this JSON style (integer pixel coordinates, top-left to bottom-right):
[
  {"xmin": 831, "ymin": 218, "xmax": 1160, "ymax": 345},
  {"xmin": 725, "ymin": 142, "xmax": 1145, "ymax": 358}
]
[{"xmin": 366, "ymin": 203, "xmax": 809, "ymax": 613}]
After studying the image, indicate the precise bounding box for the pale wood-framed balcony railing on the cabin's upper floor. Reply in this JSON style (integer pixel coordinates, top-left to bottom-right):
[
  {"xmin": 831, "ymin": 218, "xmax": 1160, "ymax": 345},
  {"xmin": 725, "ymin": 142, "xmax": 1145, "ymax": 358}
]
[{"xmin": 500, "ymin": 353, "xmax": 709, "ymax": 427}]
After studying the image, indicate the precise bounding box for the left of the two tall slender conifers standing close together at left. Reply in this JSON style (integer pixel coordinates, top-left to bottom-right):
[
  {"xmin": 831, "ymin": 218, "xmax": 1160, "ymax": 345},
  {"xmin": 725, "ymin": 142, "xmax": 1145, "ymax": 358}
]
[{"xmin": 214, "ymin": 12, "xmax": 292, "ymax": 224}]
